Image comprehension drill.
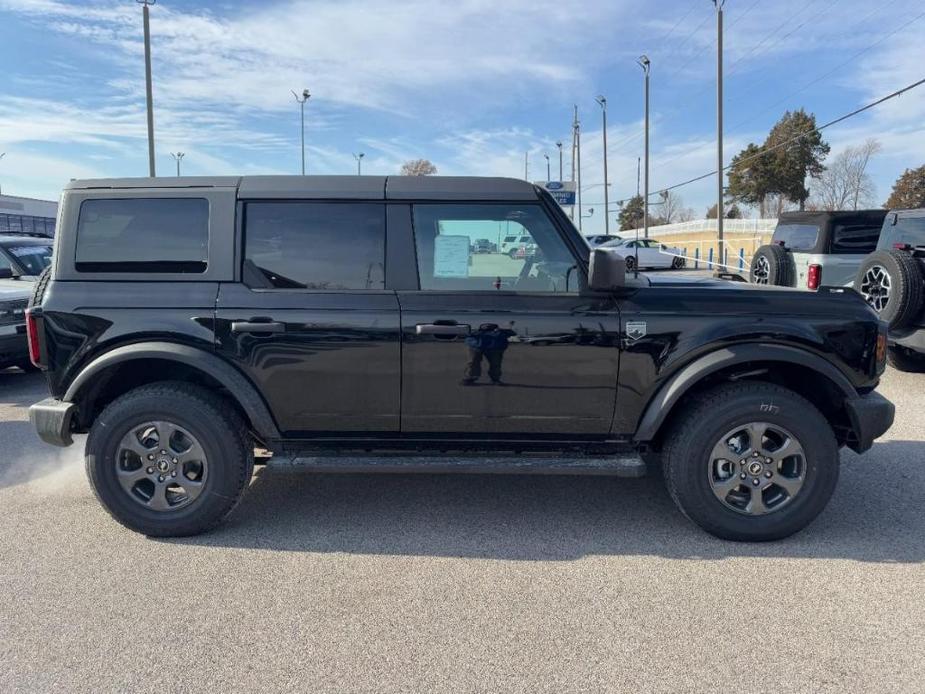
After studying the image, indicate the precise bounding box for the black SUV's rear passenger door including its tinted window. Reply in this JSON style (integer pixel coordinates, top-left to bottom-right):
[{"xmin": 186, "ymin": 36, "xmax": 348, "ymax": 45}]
[{"xmin": 216, "ymin": 200, "xmax": 400, "ymax": 438}]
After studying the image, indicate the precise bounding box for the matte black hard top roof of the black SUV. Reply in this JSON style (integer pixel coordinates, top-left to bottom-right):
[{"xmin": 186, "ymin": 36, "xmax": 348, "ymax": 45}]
[{"xmin": 66, "ymin": 176, "xmax": 539, "ymax": 201}]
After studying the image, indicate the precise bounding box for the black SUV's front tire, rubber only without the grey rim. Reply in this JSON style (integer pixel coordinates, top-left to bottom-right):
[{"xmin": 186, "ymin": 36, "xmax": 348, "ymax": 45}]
[{"xmin": 662, "ymin": 382, "xmax": 838, "ymax": 542}]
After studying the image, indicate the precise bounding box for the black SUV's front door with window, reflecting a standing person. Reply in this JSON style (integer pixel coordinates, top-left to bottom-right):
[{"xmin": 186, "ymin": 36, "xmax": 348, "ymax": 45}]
[{"xmin": 398, "ymin": 203, "xmax": 619, "ymax": 438}]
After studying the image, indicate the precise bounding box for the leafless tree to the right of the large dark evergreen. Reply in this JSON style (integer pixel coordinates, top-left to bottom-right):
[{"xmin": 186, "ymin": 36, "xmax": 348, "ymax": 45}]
[{"xmin": 812, "ymin": 138, "xmax": 883, "ymax": 210}]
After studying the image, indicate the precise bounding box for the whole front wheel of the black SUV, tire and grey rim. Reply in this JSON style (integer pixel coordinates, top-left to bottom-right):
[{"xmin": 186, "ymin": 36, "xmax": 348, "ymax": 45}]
[{"xmin": 662, "ymin": 383, "xmax": 838, "ymax": 542}]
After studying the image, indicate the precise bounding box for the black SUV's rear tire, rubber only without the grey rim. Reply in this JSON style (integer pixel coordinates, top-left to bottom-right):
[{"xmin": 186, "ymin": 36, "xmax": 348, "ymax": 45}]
[{"xmin": 86, "ymin": 381, "xmax": 254, "ymax": 537}]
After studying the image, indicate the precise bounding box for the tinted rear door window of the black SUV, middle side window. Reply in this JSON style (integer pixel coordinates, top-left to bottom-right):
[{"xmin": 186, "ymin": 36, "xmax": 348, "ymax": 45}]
[{"xmin": 244, "ymin": 202, "xmax": 385, "ymax": 290}]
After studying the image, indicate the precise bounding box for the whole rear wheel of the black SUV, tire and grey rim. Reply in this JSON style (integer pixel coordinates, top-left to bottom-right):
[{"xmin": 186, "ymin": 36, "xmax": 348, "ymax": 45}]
[{"xmin": 86, "ymin": 382, "xmax": 254, "ymax": 537}]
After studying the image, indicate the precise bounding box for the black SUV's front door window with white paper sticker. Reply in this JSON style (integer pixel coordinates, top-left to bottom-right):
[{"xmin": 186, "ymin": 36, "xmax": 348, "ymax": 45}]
[{"xmin": 414, "ymin": 205, "xmax": 578, "ymax": 292}]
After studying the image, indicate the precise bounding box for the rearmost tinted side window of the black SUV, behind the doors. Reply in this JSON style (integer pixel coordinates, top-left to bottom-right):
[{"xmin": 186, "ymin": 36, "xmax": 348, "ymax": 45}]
[{"xmin": 76, "ymin": 198, "xmax": 209, "ymax": 272}]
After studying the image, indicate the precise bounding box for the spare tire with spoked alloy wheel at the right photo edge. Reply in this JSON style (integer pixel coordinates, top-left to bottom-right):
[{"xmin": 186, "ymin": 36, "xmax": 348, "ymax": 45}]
[{"xmin": 854, "ymin": 250, "xmax": 923, "ymax": 330}]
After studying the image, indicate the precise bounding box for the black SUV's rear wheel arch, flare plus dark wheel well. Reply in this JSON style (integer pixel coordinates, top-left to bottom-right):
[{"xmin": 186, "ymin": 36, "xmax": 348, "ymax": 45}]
[{"xmin": 63, "ymin": 342, "xmax": 281, "ymax": 441}]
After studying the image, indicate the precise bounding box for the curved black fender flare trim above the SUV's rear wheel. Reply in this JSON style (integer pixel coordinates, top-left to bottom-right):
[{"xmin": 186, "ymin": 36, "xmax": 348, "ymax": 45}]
[{"xmin": 64, "ymin": 342, "xmax": 281, "ymax": 439}]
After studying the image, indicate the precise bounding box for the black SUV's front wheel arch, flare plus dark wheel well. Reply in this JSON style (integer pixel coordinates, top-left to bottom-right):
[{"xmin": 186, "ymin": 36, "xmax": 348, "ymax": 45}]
[{"xmin": 635, "ymin": 344, "xmax": 858, "ymax": 443}]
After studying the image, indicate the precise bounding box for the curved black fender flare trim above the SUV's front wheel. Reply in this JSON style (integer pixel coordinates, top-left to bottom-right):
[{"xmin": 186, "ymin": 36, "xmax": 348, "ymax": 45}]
[{"xmin": 634, "ymin": 344, "xmax": 858, "ymax": 441}]
